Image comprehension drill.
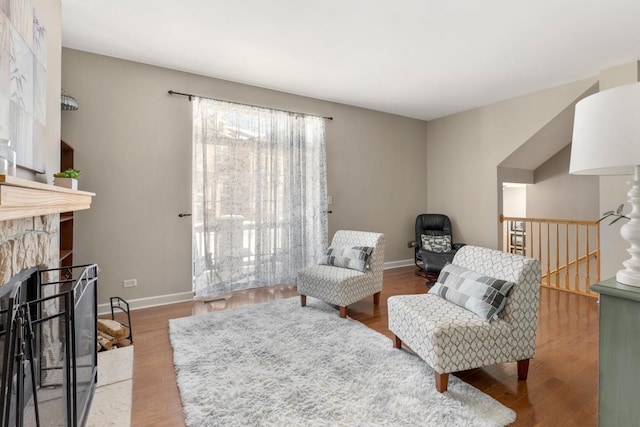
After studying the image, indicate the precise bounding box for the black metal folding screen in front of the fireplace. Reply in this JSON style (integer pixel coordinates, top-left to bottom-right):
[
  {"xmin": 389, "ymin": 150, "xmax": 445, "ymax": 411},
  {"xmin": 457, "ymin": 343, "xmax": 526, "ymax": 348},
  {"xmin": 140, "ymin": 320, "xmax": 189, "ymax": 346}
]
[{"xmin": 0, "ymin": 264, "xmax": 98, "ymax": 427}]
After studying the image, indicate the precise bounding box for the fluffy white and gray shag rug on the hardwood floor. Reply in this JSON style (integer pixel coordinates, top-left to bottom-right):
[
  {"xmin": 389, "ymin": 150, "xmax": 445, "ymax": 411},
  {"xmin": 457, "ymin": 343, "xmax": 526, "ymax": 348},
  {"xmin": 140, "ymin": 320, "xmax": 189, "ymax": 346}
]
[{"xmin": 169, "ymin": 298, "xmax": 516, "ymax": 427}]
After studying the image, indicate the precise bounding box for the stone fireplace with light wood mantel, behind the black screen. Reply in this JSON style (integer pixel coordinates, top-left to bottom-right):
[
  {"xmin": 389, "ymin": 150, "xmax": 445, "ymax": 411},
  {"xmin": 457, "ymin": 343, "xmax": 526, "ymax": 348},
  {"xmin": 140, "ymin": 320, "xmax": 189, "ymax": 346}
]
[{"xmin": 0, "ymin": 175, "xmax": 97, "ymax": 426}]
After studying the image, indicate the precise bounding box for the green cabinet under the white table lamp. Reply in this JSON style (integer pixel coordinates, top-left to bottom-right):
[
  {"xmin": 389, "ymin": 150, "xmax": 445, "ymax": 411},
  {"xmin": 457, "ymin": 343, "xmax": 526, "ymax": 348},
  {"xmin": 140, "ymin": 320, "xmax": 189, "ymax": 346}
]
[{"xmin": 591, "ymin": 278, "xmax": 640, "ymax": 427}]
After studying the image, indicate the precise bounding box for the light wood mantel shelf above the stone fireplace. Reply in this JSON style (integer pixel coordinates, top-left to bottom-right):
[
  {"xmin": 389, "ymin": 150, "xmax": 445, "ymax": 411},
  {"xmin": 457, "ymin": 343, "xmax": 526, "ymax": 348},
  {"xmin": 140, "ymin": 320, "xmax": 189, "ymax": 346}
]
[{"xmin": 0, "ymin": 175, "xmax": 95, "ymax": 221}]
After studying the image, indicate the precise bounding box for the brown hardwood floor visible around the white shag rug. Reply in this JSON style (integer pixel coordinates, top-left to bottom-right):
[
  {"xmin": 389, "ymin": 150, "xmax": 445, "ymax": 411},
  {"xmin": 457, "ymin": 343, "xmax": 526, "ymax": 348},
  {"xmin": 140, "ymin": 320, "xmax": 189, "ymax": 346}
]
[{"xmin": 125, "ymin": 267, "xmax": 598, "ymax": 427}]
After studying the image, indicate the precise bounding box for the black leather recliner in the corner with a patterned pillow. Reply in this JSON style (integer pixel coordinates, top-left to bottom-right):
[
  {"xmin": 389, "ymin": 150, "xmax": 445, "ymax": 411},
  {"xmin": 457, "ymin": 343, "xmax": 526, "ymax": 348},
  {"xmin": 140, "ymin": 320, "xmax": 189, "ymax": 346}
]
[{"xmin": 408, "ymin": 214, "xmax": 464, "ymax": 285}]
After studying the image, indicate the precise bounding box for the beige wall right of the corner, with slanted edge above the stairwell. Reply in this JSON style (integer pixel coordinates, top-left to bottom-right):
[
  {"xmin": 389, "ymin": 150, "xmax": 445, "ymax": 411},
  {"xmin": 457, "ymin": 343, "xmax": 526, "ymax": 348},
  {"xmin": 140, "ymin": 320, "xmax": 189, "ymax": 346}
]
[{"xmin": 427, "ymin": 77, "xmax": 596, "ymax": 248}]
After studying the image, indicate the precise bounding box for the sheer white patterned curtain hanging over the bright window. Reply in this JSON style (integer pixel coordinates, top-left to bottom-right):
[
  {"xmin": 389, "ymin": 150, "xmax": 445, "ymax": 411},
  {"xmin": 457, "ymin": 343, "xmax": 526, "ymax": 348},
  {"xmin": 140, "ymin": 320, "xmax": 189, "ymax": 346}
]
[{"xmin": 193, "ymin": 98, "xmax": 327, "ymax": 298}]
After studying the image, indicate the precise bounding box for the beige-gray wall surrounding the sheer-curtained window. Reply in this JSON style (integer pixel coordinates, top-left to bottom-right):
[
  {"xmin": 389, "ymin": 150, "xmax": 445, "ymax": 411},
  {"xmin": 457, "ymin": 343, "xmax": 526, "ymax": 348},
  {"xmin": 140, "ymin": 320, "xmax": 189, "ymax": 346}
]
[{"xmin": 62, "ymin": 49, "xmax": 427, "ymax": 306}]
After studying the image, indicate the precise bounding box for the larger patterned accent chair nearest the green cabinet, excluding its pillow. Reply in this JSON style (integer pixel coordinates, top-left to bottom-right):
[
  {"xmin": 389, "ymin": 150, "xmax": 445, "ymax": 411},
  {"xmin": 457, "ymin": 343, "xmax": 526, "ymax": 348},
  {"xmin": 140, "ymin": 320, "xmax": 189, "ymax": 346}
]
[{"xmin": 387, "ymin": 245, "xmax": 540, "ymax": 393}]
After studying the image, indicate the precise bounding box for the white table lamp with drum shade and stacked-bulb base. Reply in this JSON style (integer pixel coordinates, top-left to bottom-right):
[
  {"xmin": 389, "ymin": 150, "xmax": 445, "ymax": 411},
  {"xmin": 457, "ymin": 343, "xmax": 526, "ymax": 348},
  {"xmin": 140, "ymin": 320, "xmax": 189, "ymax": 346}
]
[{"xmin": 569, "ymin": 83, "xmax": 640, "ymax": 287}]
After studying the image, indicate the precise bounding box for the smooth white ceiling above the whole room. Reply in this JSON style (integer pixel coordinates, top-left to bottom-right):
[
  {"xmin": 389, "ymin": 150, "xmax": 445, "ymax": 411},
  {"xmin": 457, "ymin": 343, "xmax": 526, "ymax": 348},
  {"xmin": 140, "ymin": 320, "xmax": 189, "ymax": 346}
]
[{"xmin": 62, "ymin": 0, "xmax": 640, "ymax": 120}]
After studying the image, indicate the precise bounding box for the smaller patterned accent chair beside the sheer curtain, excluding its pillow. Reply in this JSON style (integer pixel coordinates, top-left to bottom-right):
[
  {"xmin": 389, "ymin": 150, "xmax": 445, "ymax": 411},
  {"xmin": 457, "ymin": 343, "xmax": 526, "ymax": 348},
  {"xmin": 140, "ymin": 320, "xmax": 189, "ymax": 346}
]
[{"xmin": 297, "ymin": 230, "xmax": 384, "ymax": 318}]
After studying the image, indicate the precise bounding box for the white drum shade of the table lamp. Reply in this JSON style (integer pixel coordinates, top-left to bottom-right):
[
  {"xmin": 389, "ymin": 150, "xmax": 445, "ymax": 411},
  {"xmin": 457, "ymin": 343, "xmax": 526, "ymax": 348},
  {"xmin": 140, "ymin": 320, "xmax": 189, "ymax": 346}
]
[{"xmin": 569, "ymin": 83, "xmax": 640, "ymax": 175}]
